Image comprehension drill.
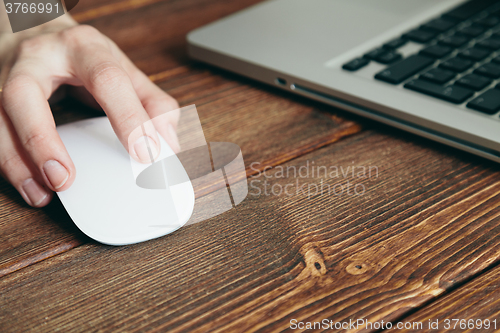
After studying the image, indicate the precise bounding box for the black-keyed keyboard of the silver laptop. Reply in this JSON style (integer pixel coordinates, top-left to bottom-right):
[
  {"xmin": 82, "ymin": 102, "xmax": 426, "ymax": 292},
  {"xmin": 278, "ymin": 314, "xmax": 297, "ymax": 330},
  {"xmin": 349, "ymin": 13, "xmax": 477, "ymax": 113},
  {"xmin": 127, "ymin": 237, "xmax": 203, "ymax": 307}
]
[{"xmin": 342, "ymin": 0, "xmax": 500, "ymax": 115}]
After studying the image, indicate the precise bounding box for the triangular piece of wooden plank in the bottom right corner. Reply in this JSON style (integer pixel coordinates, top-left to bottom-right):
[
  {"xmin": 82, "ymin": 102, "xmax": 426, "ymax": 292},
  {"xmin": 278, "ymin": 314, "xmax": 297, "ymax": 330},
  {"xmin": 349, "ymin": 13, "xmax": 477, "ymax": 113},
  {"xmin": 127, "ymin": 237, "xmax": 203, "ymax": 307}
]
[{"xmin": 401, "ymin": 266, "xmax": 500, "ymax": 332}]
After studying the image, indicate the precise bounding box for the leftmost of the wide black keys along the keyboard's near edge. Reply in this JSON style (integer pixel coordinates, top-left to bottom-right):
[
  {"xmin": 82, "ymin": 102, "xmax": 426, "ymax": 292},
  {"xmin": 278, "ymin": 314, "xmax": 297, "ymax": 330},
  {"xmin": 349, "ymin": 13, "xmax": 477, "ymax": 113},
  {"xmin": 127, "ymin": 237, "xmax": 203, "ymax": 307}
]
[{"xmin": 375, "ymin": 54, "xmax": 435, "ymax": 84}]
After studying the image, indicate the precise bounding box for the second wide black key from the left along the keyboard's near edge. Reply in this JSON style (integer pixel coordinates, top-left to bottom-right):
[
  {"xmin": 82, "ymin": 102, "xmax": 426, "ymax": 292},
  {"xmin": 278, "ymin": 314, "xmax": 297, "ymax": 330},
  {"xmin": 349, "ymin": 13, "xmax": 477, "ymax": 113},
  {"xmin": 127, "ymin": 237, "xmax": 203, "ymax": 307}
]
[{"xmin": 404, "ymin": 80, "xmax": 474, "ymax": 104}]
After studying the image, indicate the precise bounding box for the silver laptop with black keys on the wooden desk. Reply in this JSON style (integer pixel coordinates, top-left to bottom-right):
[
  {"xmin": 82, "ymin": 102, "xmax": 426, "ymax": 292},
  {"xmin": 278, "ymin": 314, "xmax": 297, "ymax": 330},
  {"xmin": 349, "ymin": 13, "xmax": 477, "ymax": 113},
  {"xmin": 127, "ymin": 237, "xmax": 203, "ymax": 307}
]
[{"xmin": 187, "ymin": 0, "xmax": 500, "ymax": 162}]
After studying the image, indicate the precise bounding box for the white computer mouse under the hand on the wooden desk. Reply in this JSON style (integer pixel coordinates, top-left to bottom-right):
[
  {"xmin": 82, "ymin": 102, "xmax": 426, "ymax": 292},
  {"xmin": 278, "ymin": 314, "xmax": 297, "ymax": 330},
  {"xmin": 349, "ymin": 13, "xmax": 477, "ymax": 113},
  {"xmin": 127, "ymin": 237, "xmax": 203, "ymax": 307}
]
[{"xmin": 57, "ymin": 117, "xmax": 195, "ymax": 245}]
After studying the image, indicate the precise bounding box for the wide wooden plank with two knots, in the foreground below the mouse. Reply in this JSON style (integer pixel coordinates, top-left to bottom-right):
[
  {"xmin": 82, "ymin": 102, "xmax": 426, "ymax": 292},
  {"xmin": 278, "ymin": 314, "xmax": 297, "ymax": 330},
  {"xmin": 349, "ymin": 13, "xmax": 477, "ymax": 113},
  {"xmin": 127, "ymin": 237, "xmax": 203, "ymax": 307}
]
[{"xmin": 0, "ymin": 127, "xmax": 500, "ymax": 332}]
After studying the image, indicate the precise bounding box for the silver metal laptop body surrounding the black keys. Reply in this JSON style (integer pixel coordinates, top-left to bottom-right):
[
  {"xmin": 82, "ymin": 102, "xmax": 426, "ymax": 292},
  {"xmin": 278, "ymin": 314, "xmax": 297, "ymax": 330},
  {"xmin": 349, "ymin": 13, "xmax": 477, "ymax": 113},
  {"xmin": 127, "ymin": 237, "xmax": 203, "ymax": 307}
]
[{"xmin": 188, "ymin": 0, "xmax": 500, "ymax": 162}]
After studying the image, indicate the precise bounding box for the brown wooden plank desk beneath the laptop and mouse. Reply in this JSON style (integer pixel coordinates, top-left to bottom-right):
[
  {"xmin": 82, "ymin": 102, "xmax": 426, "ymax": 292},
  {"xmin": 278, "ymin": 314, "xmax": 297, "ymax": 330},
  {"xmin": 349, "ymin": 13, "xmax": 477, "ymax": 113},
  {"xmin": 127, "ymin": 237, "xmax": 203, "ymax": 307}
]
[{"xmin": 0, "ymin": 0, "xmax": 500, "ymax": 332}]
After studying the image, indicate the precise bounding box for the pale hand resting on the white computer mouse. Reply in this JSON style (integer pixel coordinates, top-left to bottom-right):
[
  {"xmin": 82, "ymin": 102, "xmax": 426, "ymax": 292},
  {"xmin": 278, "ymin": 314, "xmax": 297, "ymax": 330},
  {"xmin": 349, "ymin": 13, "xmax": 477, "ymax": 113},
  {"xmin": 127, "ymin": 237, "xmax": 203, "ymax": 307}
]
[{"xmin": 0, "ymin": 15, "xmax": 180, "ymax": 207}]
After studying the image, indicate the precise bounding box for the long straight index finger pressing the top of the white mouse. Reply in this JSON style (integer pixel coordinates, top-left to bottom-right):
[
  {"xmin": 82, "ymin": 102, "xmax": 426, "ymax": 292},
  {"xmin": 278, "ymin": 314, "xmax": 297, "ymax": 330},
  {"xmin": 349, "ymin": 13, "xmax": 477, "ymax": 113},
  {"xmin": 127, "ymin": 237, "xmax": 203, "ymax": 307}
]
[{"xmin": 65, "ymin": 26, "xmax": 160, "ymax": 163}]
